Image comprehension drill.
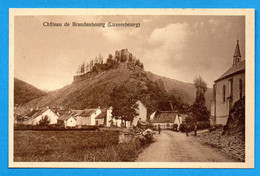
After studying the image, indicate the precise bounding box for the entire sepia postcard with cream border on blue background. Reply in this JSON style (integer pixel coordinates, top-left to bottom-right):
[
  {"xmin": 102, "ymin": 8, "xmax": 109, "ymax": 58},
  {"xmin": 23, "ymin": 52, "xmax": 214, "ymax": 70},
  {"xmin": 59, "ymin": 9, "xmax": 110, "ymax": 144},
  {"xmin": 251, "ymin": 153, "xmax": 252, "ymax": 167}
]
[{"xmin": 9, "ymin": 9, "xmax": 254, "ymax": 168}]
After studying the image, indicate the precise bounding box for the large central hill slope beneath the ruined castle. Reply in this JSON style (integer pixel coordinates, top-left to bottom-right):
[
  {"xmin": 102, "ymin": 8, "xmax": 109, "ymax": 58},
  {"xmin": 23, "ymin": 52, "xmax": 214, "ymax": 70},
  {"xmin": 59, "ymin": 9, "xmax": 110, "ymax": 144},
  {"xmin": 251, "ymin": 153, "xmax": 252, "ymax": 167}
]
[{"xmin": 22, "ymin": 63, "xmax": 212, "ymax": 111}]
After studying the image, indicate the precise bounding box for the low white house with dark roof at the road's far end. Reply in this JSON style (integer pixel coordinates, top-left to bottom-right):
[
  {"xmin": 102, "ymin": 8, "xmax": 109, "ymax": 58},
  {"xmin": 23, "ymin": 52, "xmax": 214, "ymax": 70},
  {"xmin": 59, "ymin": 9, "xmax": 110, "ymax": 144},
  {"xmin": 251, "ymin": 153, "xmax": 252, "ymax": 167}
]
[{"xmin": 150, "ymin": 111, "xmax": 179, "ymax": 129}]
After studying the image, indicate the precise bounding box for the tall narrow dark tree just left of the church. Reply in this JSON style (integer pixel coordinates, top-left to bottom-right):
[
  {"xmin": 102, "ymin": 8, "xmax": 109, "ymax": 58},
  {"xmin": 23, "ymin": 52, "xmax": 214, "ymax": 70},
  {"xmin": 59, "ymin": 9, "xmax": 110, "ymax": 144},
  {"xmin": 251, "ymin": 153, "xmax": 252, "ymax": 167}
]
[{"xmin": 191, "ymin": 76, "xmax": 210, "ymax": 121}]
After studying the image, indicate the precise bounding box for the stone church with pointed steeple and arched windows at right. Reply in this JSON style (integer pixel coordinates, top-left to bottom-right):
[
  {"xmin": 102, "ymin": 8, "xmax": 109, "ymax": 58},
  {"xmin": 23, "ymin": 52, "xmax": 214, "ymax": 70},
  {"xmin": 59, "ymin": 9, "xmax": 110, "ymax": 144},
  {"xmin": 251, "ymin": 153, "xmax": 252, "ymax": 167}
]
[{"xmin": 210, "ymin": 41, "xmax": 245, "ymax": 125}]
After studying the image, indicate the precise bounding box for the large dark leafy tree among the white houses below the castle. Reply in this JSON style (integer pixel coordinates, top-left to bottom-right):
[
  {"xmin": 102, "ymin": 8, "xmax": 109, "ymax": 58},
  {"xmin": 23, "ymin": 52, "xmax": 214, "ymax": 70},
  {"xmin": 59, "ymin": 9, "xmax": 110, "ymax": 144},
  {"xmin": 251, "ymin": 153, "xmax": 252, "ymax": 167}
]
[{"xmin": 110, "ymin": 84, "xmax": 139, "ymax": 124}]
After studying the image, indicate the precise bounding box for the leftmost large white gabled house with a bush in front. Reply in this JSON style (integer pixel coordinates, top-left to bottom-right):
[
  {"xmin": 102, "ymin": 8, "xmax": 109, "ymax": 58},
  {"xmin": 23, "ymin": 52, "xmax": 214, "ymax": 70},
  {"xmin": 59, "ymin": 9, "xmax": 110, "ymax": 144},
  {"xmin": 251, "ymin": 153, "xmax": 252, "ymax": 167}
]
[{"xmin": 23, "ymin": 108, "xmax": 59, "ymax": 125}]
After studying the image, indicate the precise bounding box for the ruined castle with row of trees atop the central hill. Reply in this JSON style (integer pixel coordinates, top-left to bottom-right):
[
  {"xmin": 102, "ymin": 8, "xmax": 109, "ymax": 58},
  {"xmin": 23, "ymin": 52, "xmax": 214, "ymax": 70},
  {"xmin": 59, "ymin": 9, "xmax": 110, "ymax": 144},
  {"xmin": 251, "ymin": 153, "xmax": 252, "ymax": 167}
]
[{"xmin": 74, "ymin": 49, "xmax": 143, "ymax": 82}]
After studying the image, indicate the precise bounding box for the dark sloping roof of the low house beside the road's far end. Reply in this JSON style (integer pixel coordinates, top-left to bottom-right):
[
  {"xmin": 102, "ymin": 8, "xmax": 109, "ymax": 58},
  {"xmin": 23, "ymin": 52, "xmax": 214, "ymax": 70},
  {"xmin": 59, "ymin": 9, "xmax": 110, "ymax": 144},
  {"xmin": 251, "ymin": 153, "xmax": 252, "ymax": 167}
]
[{"xmin": 151, "ymin": 111, "xmax": 177, "ymax": 123}]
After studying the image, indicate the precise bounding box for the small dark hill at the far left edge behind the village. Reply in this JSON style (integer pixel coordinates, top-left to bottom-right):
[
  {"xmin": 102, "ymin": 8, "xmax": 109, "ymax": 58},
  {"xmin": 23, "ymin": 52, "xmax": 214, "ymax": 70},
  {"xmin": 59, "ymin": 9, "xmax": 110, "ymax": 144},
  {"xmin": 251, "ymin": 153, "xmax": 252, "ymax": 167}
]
[{"xmin": 14, "ymin": 78, "xmax": 46, "ymax": 105}]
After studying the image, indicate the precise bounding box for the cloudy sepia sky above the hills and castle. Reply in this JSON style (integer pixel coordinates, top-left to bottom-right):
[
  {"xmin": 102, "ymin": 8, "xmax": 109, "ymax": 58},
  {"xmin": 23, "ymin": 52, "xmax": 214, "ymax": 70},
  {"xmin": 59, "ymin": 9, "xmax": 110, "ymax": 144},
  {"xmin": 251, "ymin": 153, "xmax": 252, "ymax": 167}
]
[{"xmin": 14, "ymin": 15, "xmax": 245, "ymax": 91}]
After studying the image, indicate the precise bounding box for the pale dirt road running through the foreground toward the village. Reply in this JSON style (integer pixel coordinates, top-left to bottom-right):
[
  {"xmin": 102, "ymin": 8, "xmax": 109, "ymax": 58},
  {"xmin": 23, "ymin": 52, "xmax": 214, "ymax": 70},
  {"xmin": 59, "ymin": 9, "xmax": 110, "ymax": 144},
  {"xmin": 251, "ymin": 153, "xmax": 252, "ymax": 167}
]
[{"xmin": 136, "ymin": 131, "xmax": 237, "ymax": 162}]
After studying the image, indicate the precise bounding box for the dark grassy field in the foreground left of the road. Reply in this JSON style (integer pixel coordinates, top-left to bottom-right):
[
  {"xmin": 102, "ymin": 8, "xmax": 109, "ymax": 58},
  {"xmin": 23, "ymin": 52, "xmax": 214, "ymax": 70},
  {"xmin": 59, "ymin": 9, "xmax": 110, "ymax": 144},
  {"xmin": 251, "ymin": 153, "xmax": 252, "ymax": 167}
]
[{"xmin": 14, "ymin": 130, "xmax": 145, "ymax": 162}]
